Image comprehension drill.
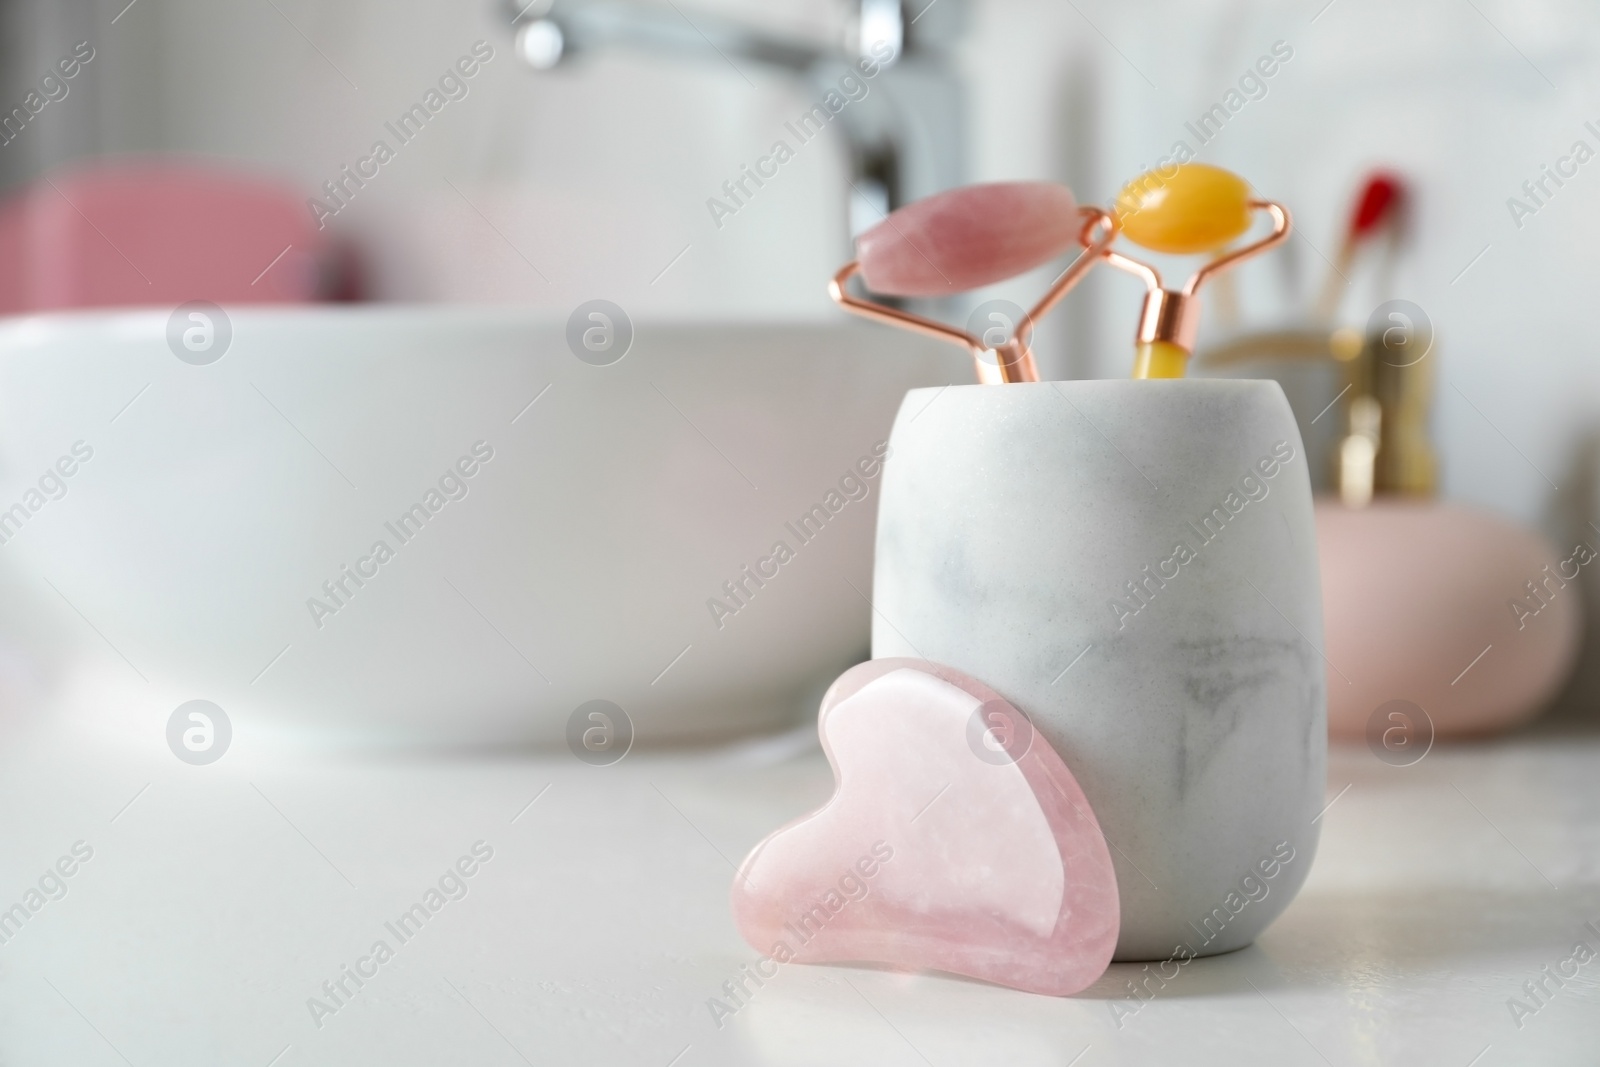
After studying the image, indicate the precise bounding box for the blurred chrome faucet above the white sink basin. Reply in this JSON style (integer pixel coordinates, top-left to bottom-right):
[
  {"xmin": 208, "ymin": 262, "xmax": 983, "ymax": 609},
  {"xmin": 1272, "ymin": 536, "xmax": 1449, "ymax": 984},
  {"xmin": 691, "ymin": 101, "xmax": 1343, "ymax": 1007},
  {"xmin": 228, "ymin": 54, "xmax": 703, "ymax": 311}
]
[{"xmin": 504, "ymin": 0, "xmax": 966, "ymax": 235}]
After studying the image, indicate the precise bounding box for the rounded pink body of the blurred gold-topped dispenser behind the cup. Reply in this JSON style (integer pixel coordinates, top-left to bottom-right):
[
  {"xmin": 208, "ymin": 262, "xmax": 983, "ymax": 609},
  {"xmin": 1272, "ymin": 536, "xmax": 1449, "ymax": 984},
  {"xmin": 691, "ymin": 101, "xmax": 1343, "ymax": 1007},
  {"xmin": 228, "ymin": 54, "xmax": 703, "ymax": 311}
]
[{"xmin": 1317, "ymin": 499, "xmax": 1595, "ymax": 739}]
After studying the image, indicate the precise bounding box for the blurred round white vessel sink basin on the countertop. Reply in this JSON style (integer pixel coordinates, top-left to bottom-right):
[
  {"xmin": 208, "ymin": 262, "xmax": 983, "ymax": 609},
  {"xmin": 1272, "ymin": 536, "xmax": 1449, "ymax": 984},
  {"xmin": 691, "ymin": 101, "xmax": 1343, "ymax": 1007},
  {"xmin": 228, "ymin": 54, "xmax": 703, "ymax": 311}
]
[{"xmin": 0, "ymin": 307, "xmax": 970, "ymax": 745}]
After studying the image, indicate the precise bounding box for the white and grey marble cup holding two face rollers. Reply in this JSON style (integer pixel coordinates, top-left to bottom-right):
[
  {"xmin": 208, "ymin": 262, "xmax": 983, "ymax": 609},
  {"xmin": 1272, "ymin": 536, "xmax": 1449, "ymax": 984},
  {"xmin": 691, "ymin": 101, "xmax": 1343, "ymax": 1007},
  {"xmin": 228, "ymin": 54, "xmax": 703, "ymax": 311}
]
[{"xmin": 872, "ymin": 379, "xmax": 1338, "ymax": 960}]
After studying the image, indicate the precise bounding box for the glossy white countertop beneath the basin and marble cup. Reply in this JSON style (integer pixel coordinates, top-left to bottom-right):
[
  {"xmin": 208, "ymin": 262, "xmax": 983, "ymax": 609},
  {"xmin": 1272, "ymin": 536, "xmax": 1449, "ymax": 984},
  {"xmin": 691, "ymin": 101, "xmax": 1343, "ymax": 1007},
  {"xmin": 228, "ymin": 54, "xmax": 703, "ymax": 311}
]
[{"xmin": 0, "ymin": 703, "xmax": 1600, "ymax": 1067}]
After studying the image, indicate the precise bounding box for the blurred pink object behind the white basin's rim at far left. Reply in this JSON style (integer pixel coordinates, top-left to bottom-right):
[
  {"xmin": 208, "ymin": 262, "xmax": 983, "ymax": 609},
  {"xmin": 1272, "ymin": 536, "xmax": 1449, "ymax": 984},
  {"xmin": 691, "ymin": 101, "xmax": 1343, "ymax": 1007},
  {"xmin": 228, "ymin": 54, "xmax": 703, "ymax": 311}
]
[{"xmin": 0, "ymin": 160, "xmax": 333, "ymax": 314}]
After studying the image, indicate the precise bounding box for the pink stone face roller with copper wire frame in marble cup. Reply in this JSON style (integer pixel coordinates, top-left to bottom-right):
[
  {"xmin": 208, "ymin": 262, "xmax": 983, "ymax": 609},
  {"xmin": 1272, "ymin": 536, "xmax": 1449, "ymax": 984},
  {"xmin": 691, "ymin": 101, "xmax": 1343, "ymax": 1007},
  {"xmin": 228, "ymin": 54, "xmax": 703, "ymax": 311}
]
[{"xmin": 827, "ymin": 181, "xmax": 1115, "ymax": 384}]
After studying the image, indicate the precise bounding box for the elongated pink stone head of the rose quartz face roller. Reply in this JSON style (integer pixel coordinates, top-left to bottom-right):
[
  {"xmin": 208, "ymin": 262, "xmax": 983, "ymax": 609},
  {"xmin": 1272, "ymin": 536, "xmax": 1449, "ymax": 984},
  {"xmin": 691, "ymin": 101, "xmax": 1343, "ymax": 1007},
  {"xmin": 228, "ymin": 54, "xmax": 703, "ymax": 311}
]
[{"xmin": 856, "ymin": 181, "xmax": 1082, "ymax": 296}]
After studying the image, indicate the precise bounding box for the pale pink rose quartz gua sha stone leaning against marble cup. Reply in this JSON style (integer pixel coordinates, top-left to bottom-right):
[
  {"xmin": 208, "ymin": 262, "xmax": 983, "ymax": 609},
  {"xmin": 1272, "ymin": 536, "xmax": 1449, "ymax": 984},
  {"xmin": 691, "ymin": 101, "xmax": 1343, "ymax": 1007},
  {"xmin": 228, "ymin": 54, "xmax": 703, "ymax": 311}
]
[{"xmin": 733, "ymin": 659, "xmax": 1120, "ymax": 997}]
